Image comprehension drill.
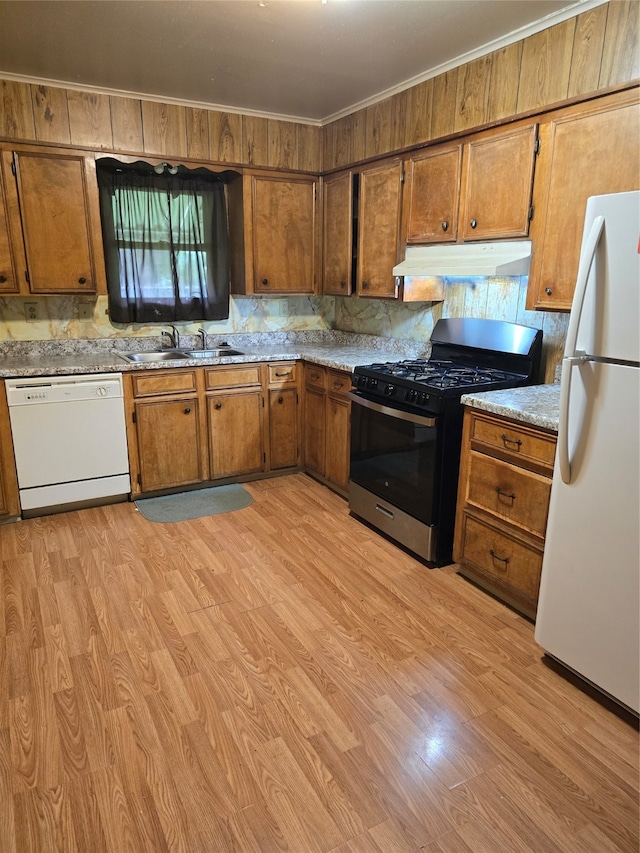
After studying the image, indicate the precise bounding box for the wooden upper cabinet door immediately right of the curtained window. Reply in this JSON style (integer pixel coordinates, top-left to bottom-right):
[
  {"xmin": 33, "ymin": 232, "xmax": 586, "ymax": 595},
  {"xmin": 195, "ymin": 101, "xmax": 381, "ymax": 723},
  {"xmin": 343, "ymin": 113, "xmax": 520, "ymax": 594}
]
[{"xmin": 251, "ymin": 175, "xmax": 317, "ymax": 293}]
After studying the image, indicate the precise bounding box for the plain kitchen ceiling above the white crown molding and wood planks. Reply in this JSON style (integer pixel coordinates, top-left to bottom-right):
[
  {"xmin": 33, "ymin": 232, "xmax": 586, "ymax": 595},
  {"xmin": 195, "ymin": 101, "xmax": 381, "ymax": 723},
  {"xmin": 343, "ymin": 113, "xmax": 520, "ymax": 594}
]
[{"xmin": 0, "ymin": 0, "xmax": 602, "ymax": 123}]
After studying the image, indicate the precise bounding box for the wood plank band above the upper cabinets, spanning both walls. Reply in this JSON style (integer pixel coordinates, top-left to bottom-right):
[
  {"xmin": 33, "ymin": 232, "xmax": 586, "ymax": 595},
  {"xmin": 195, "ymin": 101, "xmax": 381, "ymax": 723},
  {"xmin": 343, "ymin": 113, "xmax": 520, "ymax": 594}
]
[{"xmin": 0, "ymin": 0, "xmax": 640, "ymax": 172}]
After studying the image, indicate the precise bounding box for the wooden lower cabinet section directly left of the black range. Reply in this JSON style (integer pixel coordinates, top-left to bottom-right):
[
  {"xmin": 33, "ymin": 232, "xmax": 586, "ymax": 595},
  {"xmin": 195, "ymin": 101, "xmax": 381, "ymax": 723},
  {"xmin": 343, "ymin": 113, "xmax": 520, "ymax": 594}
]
[{"xmin": 304, "ymin": 364, "xmax": 351, "ymax": 495}]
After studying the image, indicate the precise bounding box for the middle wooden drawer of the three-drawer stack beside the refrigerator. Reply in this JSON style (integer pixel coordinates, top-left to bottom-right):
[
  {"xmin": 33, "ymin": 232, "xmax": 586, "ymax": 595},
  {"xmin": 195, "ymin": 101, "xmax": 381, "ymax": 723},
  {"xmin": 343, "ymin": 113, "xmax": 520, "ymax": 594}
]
[{"xmin": 466, "ymin": 451, "xmax": 551, "ymax": 537}]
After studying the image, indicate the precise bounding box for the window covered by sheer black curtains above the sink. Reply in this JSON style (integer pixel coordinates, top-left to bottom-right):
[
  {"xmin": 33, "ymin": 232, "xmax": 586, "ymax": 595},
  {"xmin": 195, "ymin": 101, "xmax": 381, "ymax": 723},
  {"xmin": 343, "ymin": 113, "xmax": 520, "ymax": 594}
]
[{"xmin": 98, "ymin": 160, "xmax": 229, "ymax": 323}]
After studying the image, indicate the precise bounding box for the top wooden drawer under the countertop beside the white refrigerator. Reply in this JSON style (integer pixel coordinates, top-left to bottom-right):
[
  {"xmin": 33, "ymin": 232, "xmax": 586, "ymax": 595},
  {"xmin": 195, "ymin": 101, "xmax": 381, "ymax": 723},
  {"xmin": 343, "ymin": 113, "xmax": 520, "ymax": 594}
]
[{"xmin": 471, "ymin": 413, "xmax": 556, "ymax": 474}]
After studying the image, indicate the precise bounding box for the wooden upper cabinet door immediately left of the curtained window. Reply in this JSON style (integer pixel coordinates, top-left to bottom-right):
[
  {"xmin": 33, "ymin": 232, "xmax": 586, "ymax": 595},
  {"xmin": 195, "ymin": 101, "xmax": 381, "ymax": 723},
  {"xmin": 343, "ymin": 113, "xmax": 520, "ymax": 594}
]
[{"xmin": 5, "ymin": 151, "xmax": 97, "ymax": 293}]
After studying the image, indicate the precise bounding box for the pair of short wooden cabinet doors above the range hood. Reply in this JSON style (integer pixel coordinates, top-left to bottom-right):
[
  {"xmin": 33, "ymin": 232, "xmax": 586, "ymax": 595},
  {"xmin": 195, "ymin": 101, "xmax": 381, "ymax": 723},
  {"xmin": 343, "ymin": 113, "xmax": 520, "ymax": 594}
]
[{"xmin": 405, "ymin": 124, "xmax": 537, "ymax": 244}]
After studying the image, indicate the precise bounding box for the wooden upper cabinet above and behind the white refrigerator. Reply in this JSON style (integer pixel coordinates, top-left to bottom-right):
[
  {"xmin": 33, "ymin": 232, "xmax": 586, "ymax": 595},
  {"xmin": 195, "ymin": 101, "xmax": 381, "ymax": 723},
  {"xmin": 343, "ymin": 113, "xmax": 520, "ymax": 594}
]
[{"xmin": 527, "ymin": 89, "xmax": 640, "ymax": 311}]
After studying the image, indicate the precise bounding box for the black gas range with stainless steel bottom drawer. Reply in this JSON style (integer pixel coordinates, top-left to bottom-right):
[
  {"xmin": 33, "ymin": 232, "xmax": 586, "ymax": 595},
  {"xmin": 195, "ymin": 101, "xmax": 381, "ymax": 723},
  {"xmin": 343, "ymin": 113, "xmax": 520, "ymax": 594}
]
[{"xmin": 349, "ymin": 318, "xmax": 542, "ymax": 566}]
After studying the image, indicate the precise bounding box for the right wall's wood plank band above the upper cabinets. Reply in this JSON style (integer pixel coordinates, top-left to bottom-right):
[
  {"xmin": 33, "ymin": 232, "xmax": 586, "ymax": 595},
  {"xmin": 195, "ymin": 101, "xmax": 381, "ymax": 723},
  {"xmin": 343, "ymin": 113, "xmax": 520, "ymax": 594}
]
[{"xmin": 323, "ymin": 0, "xmax": 640, "ymax": 171}]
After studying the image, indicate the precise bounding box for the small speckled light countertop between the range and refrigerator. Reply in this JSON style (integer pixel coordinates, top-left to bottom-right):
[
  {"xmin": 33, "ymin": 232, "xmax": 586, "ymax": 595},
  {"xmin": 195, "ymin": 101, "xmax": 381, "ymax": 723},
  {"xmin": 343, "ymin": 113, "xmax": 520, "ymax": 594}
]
[{"xmin": 462, "ymin": 384, "xmax": 560, "ymax": 433}]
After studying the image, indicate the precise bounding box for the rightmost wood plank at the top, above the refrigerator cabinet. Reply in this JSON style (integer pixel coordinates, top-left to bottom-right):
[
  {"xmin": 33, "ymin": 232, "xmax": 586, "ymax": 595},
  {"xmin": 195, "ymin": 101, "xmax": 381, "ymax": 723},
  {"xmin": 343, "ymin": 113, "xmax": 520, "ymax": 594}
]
[{"xmin": 599, "ymin": 0, "xmax": 640, "ymax": 89}]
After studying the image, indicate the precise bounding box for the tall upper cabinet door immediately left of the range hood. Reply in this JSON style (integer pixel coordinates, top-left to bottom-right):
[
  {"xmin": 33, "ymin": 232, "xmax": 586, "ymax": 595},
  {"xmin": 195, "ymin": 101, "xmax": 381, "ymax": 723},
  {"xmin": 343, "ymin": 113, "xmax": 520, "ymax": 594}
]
[{"xmin": 357, "ymin": 160, "xmax": 403, "ymax": 298}]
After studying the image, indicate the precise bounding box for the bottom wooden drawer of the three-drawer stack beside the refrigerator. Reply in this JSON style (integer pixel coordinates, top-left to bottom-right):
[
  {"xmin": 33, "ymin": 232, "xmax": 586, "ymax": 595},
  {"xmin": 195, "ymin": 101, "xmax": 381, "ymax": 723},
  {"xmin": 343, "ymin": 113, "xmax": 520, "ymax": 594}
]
[{"xmin": 460, "ymin": 512, "xmax": 542, "ymax": 611}]
